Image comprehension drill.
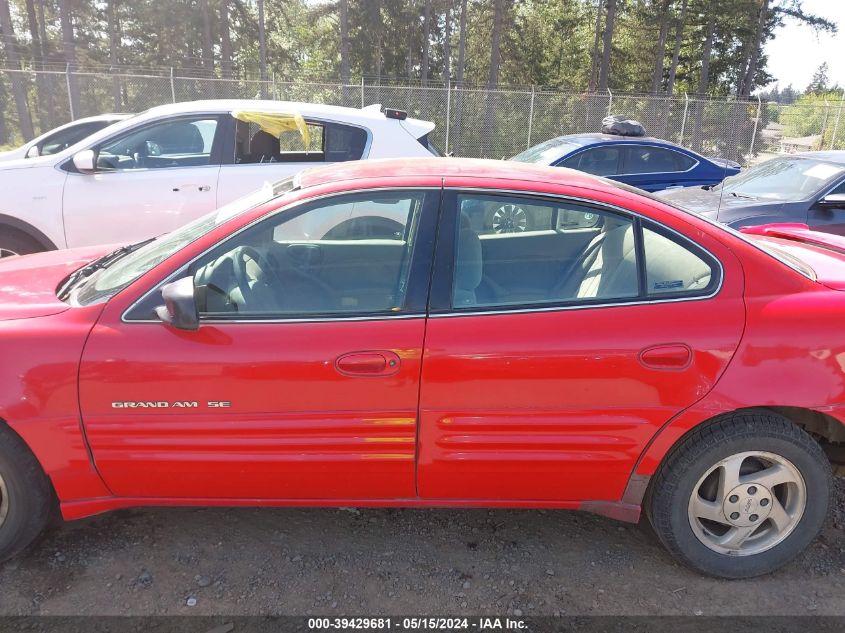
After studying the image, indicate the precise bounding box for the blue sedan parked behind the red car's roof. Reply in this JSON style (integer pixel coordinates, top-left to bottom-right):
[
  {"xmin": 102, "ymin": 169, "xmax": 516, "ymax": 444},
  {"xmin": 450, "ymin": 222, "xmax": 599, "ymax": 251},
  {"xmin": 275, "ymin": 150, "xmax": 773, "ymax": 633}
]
[{"xmin": 511, "ymin": 134, "xmax": 740, "ymax": 191}]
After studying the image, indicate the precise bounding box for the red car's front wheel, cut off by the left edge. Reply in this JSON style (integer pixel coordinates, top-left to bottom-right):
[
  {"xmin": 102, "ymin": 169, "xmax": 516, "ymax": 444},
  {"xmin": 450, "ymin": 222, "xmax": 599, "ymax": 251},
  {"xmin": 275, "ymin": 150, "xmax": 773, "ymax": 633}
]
[{"xmin": 0, "ymin": 428, "xmax": 53, "ymax": 563}]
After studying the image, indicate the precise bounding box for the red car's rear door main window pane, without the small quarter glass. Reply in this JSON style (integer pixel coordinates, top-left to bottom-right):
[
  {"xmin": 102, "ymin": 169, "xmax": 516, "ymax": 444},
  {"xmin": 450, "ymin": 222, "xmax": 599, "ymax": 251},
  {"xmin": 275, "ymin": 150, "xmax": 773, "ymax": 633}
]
[{"xmin": 452, "ymin": 194, "xmax": 639, "ymax": 308}]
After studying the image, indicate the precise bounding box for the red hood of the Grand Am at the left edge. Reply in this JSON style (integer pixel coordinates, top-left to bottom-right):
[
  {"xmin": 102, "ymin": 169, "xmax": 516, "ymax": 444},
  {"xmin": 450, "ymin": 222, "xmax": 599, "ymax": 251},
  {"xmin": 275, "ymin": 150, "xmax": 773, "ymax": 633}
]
[{"xmin": 0, "ymin": 246, "xmax": 109, "ymax": 321}]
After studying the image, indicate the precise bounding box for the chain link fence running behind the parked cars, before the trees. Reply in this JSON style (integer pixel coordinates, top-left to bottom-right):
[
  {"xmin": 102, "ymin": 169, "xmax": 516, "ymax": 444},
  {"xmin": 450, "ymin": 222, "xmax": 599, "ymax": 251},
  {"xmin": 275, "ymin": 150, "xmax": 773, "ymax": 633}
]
[{"xmin": 0, "ymin": 70, "xmax": 845, "ymax": 165}]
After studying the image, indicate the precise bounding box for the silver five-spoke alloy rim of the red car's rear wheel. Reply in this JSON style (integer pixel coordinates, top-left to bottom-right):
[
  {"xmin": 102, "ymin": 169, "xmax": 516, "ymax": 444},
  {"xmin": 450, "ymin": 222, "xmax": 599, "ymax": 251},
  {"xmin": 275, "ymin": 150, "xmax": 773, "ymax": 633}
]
[{"xmin": 688, "ymin": 451, "xmax": 807, "ymax": 556}]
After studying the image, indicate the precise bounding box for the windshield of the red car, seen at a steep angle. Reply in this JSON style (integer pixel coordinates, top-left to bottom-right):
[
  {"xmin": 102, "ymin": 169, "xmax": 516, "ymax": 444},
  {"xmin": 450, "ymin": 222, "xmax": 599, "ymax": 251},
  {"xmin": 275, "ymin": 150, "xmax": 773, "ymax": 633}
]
[{"xmin": 73, "ymin": 176, "xmax": 295, "ymax": 305}]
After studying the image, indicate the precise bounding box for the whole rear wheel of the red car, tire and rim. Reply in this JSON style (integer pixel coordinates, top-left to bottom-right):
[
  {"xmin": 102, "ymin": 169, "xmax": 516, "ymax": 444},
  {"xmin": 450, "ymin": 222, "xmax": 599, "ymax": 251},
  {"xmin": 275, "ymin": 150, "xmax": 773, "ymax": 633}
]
[{"xmin": 647, "ymin": 410, "xmax": 832, "ymax": 578}]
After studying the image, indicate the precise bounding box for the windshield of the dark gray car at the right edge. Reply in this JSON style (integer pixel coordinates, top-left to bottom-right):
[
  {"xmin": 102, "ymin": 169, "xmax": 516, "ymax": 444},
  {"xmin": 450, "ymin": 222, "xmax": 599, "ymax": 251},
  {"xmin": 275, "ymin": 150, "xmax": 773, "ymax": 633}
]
[{"xmin": 714, "ymin": 156, "xmax": 845, "ymax": 200}]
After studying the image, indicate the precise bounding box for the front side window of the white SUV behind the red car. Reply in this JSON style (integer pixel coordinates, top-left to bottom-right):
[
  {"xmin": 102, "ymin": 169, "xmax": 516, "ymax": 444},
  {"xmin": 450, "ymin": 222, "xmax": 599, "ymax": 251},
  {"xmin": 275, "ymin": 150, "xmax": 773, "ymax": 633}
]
[{"xmin": 97, "ymin": 117, "xmax": 218, "ymax": 171}]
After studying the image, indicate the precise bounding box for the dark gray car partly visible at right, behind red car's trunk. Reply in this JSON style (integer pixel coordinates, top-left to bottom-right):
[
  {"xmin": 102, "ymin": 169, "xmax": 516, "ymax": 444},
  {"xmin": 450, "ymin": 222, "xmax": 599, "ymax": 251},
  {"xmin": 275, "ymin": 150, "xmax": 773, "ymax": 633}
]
[{"xmin": 655, "ymin": 151, "xmax": 845, "ymax": 235}]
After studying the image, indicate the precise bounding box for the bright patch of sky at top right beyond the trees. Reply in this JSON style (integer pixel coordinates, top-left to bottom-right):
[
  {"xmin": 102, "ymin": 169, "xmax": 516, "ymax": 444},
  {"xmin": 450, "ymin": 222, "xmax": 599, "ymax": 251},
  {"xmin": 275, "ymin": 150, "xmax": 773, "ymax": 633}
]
[{"xmin": 766, "ymin": 0, "xmax": 845, "ymax": 90}]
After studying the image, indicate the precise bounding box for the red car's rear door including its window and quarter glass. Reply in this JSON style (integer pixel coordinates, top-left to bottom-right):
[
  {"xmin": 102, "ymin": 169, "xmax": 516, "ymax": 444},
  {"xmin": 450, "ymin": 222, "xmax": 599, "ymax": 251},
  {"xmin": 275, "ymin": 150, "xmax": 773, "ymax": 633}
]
[{"xmin": 418, "ymin": 188, "xmax": 744, "ymax": 501}]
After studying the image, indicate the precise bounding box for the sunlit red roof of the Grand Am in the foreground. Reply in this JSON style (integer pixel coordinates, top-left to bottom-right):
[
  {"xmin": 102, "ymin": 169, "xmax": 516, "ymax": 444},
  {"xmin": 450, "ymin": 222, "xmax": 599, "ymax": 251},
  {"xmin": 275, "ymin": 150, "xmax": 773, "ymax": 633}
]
[{"xmin": 297, "ymin": 157, "xmax": 614, "ymax": 190}]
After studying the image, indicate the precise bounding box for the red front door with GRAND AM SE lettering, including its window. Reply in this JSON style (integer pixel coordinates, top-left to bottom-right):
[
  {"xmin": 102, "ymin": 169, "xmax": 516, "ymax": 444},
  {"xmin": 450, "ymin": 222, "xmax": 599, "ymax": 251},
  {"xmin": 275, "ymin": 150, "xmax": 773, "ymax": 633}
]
[{"xmin": 79, "ymin": 190, "xmax": 439, "ymax": 500}]
